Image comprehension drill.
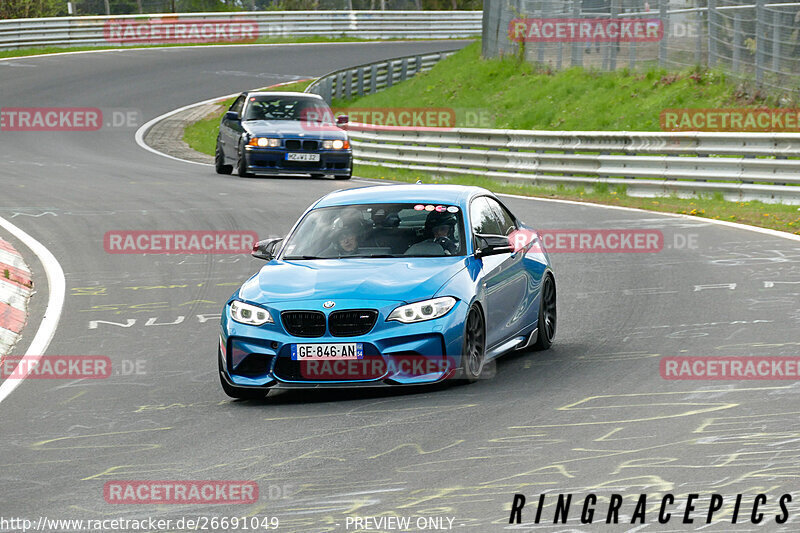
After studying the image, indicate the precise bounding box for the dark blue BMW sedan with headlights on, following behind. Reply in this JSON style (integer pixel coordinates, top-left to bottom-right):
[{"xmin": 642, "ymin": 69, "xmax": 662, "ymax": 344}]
[{"xmin": 214, "ymin": 92, "xmax": 353, "ymax": 179}]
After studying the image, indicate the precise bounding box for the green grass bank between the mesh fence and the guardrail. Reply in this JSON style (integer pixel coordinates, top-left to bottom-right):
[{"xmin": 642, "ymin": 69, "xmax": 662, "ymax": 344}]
[{"xmin": 333, "ymin": 43, "xmax": 785, "ymax": 131}]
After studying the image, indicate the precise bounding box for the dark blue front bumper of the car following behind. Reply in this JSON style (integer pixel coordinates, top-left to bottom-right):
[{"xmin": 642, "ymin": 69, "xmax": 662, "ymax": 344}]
[{"xmin": 244, "ymin": 146, "xmax": 353, "ymax": 176}]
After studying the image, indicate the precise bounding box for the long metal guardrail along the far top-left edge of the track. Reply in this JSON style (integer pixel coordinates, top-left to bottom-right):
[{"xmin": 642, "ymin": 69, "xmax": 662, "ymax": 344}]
[{"xmin": 0, "ymin": 11, "xmax": 482, "ymax": 50}]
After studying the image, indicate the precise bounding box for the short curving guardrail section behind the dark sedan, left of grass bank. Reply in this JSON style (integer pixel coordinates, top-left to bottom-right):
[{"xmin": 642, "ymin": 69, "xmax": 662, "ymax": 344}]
[{"xmin": 305, "ymin": 50, "xmax": 456, "ymax": 103}]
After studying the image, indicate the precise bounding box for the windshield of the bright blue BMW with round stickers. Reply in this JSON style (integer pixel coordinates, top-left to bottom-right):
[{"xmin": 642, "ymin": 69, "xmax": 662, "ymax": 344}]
[{"xmin": 283, "ymin": 204, "xmax": 466, "ymax": 259}]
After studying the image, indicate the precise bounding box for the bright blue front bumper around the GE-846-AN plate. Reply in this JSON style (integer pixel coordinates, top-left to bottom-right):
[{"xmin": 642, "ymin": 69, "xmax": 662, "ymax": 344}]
[{"xmin": 218, "ymin": 300, "xmax": 467, "ymax": 388}]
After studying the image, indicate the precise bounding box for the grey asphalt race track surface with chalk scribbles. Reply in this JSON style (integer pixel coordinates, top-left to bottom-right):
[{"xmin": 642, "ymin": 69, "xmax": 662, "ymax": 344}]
[{"xmin": 0, "ymin": 42, "xmax": 800, "ymax": 532}]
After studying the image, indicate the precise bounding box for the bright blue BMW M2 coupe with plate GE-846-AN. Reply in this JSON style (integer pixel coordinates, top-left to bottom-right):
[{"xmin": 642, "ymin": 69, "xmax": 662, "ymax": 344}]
[{"xmin": 217, "ymin": 184, "xmax": 556, "ymax": 398}]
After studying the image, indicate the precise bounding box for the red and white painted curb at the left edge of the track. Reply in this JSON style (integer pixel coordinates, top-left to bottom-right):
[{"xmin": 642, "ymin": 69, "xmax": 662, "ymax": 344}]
[{"xmin": 0, "ymin": 239, "xmax": 33, "ymax": 357}]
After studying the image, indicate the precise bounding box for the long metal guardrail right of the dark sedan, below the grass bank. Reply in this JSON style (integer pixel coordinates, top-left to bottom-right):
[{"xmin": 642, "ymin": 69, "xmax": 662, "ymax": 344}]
[{"xmin": 348, "ymin": 124, "xmax": 800, "ymax": 203}]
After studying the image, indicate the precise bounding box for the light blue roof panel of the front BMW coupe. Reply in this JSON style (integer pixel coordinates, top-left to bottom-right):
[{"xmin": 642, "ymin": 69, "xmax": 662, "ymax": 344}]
[{"xmin": 314, "ymin": 183, "xmax": 493, "ymax": 208}]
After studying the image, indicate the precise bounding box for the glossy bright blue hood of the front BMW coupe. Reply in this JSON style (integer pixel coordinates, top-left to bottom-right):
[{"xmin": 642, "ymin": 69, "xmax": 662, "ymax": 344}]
[{"xmin": 239, "ymin": 257, "xmax": 466, "ymax": 303}]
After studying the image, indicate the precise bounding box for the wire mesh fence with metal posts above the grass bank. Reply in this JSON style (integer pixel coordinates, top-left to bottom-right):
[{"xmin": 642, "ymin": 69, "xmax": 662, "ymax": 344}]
[{"xmin": 483, "ymin": 0, "xmax": 800, "ymax": 96}]
